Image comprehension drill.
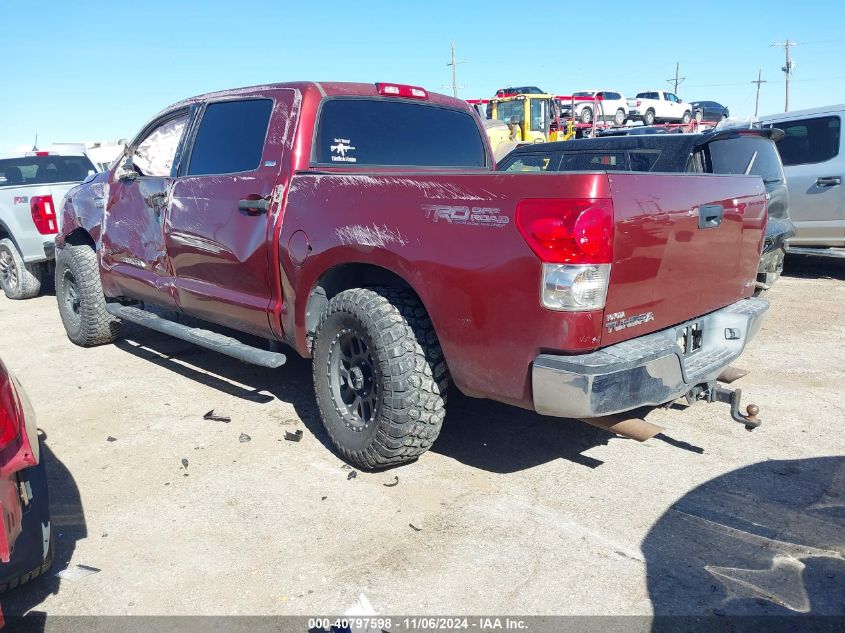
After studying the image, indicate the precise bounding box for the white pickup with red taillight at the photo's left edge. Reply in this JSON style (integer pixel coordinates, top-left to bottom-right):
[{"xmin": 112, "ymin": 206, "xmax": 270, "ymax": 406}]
[{"xmin": 0, "ymin": 151, "xmax": 97, "ymax": 299}]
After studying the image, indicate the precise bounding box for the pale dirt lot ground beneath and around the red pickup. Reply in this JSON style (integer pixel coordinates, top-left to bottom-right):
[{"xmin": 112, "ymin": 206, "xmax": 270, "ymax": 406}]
[{"xmin": 0, "ymin": 253, "xmax": 845, "ymax": 614}]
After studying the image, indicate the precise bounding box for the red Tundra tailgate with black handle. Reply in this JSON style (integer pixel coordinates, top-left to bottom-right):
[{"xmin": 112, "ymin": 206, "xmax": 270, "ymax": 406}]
[{"xmin": 601, "ymin": 173, "xmax": 766, "ymax": 346}]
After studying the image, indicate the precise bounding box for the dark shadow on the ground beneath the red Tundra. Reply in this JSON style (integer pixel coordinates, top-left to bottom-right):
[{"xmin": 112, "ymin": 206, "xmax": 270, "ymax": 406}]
[{"xmin": 115, "ymin": 324, "xmax": 628, "ymax": 473}]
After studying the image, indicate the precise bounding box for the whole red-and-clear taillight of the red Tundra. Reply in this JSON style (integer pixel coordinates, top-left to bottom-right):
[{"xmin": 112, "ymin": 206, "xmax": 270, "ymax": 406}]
[{"xmin": 516, "ymin": 198, "xmax": 613, "ymax": 311}]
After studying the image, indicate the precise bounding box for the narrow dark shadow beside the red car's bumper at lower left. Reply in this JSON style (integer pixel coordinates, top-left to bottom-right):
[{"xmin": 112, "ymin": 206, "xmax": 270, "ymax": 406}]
[{"xmin": 0, "ymin": 435, "xmax": 88, "ymax": 631}]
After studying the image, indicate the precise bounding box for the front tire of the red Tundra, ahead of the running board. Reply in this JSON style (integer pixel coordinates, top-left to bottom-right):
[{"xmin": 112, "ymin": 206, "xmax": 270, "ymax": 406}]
[{"xmin": 56, "ymin": 244, "xmax": 120, "ymax": 347}]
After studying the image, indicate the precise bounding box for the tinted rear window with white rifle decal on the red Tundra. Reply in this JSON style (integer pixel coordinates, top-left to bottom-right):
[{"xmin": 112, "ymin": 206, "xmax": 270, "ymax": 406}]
[{"xmin": 315, "ymin": 99, "xmax": 487, "ymax": 168}]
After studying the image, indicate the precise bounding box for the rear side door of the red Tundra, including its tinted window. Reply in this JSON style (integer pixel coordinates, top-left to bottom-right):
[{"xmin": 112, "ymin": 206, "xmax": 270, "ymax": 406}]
[{"xmin": 166, "ymin": 89, "xmax": 299, "ymax": 336}]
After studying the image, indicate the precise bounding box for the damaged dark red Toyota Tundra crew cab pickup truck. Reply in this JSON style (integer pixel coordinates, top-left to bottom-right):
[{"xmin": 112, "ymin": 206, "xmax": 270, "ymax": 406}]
[{"xmin": 56, "ymin": 83, "xmax": 768, "ymax": 468}]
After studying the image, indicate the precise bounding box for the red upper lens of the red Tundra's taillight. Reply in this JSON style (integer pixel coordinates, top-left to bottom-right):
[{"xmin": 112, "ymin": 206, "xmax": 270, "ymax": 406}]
[{"xmin": 516, "ymin": 198, "xmax": 613, "ymax": 264}]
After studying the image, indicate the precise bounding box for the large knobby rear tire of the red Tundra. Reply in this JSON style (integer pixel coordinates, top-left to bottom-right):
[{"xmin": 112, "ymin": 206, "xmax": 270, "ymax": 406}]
[{"xmin": 313, "ymin": 287, "xmax": 449, "ymax": 470}]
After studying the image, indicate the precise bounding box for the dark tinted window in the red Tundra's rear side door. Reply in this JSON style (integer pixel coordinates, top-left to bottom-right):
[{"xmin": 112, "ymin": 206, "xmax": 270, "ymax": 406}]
[{"xmin": 188, "ymin": 99, "xmax": 273, "ymax": 176}]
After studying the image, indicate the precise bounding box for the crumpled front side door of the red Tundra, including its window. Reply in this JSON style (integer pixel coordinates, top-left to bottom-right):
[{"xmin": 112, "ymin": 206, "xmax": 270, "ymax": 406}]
[{"xmin": 100, "ymin": 108, "xmax": 189, "ymax": 308}]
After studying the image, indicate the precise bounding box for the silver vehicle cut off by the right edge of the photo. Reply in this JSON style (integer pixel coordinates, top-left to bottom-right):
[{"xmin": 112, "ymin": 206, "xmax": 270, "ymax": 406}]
[{"xmin": 760, "ymin": 104, "xmax": 845, "ymax": 257}]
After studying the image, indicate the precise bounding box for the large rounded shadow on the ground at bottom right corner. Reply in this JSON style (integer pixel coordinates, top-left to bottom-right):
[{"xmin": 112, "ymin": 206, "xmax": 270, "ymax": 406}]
[{"xmin": 642, "ymin": 456, "xmax": 845, "ymax": 631}]
